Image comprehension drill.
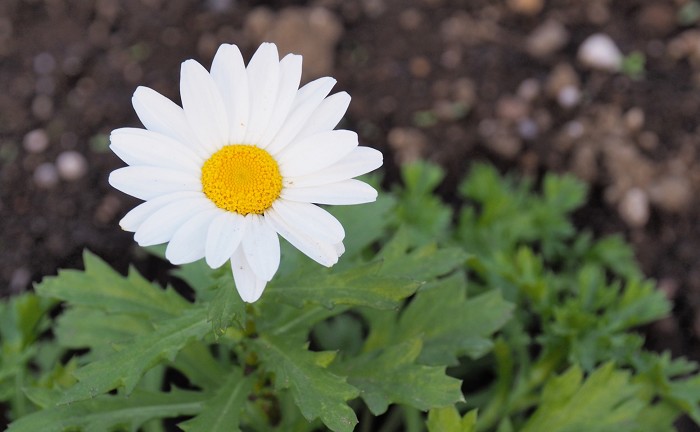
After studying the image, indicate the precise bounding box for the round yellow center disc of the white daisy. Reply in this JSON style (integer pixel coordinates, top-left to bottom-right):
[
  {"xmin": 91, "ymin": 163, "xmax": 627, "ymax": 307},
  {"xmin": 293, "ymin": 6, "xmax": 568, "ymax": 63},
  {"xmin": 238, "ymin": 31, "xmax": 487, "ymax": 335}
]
[{"xmin": 202, "ymin": 144, "xmax": 282, "ymax": 215}]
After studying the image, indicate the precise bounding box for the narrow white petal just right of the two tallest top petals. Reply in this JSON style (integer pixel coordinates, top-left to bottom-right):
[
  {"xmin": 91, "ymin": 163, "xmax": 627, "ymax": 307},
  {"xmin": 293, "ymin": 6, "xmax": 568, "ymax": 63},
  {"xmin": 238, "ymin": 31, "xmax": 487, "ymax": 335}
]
[{"xmin": 258, "ymin": 54, "xmax": 301, "ymax": 148}]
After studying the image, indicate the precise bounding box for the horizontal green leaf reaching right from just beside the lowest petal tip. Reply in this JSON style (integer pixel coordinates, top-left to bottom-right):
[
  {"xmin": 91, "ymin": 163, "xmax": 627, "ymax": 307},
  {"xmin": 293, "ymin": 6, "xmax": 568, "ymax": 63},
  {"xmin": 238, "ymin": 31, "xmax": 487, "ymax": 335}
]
[{"xmin": 263, "ymin": 262, "xmax": 419, "ymax": 309}]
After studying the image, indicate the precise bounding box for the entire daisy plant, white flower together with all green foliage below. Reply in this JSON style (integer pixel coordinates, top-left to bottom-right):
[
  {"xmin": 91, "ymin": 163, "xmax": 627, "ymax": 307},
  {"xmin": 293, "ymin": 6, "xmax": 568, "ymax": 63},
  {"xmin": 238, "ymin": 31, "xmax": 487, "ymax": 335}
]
[{"xmin": 0, "ymin": 44, "xmax": 700, "ymax": 432}]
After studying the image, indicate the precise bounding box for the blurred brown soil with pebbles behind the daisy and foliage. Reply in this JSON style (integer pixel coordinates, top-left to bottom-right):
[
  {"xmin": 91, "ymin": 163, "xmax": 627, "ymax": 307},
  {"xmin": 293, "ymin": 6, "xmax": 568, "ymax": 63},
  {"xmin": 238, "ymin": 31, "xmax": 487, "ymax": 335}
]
[{"xmin": 0, "ymin": 0, "xmax": 700, "ymax": 359}]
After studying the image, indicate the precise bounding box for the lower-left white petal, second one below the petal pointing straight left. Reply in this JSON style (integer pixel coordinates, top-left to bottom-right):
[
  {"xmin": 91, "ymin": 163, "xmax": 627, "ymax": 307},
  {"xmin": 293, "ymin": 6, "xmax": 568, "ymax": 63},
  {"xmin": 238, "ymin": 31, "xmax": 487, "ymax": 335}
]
[{"xmin": 134, "ymin": 197, "xmax": 216, "ymax": 246}]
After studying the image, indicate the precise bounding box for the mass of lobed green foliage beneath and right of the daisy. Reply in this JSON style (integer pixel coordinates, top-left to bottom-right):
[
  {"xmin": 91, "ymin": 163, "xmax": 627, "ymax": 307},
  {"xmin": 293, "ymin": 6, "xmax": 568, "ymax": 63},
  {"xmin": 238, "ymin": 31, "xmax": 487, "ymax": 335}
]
[{"xmin": 0, "ymin": 163, "xmax": 700, "ymax": 432}]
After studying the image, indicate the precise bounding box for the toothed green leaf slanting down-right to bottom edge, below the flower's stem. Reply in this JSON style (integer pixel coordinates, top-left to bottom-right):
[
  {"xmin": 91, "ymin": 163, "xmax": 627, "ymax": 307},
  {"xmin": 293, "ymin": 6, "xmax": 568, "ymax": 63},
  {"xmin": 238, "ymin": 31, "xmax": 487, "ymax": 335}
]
[{"xmin": 254, "ymin": 335, "xmax": 359, "ymax": 432}]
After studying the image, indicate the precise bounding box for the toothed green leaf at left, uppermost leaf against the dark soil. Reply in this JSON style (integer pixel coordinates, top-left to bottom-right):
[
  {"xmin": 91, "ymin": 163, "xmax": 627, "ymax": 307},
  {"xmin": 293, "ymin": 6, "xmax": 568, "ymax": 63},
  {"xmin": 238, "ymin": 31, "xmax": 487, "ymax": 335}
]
[{"xmin": 36, "ymin": 251, "xmax": 191, "ymax": 319}]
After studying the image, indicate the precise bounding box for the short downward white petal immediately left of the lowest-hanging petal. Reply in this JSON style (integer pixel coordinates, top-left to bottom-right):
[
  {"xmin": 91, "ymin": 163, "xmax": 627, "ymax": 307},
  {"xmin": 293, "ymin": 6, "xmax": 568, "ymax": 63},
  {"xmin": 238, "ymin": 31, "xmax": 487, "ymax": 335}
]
[{"xmin": 205, "ymin": 211, "xmax": 248, "ymax": 268}]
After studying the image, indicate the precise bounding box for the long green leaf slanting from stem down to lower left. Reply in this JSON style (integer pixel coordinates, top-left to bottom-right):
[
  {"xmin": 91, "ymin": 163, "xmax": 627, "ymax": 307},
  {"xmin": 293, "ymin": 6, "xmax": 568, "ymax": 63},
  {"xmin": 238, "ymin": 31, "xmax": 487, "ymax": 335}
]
[{"xmin": 60, "ymin": 309, "xmax": 211, "ymax": 403}]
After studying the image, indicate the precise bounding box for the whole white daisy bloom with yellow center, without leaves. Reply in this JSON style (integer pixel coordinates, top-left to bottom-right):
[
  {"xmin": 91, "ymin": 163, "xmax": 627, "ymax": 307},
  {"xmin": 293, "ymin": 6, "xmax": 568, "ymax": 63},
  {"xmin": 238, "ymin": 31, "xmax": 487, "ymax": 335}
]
[{"xmin": 109, "ymin": 43, "xmax": 382, "ymax": 302}]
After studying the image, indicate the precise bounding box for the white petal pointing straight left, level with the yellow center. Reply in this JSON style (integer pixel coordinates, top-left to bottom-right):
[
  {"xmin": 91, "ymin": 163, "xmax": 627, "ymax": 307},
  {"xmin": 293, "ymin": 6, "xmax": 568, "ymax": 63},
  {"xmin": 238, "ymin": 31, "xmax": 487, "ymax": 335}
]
[{"xmin": 109, "ymin": 166, "xmax": 202, "ymax": 200}]
